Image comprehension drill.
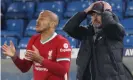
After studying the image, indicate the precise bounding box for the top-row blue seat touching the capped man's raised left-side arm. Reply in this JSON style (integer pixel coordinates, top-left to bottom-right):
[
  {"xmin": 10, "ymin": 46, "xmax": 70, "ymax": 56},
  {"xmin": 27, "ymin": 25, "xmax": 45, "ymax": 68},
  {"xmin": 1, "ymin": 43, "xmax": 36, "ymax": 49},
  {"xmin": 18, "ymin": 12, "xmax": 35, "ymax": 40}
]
[{"xmin": 64, "ymin": 1, "xmax": 92, "ymax": 18}]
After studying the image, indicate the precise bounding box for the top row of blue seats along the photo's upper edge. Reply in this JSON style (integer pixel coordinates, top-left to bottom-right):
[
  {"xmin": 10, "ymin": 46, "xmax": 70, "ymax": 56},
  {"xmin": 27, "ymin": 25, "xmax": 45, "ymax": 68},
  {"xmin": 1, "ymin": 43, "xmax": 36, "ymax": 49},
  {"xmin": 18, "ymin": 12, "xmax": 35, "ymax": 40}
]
[{"xmin": 3, "ymin": 0, "xmax": 133, "ymax": 19}]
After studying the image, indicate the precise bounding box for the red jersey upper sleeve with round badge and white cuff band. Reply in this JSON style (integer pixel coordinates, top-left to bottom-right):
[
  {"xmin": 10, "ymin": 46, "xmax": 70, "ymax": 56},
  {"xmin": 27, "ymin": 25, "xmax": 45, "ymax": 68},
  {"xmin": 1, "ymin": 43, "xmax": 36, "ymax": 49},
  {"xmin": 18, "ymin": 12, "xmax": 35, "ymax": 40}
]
[{"xmin": 56, "ymin": 40, "xmax": 72, "ymax": 62}]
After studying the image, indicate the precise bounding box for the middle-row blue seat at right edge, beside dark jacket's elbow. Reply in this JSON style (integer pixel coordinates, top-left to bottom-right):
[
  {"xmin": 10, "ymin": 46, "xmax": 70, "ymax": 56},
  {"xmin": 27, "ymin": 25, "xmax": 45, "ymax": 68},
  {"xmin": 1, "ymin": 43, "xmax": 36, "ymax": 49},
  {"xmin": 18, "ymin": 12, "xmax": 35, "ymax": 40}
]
[{"xmin": 121, "ymin": 18, "xmax": 133, "ymax": 35}]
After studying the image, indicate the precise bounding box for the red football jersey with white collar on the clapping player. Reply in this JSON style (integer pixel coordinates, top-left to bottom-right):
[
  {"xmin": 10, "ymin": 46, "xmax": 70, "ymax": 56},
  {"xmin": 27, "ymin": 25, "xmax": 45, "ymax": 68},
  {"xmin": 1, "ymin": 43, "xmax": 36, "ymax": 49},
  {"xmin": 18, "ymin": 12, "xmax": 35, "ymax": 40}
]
[{"xmin": 14, "ymin": 33, "xmax": 71, "ymax": 80}]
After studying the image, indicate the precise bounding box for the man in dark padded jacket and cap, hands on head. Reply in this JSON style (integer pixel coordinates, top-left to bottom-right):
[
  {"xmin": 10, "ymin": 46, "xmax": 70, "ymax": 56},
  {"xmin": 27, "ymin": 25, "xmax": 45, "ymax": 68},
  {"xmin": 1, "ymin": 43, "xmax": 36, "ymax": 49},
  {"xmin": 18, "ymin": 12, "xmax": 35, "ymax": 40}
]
[{"xmin": 63, "ymin": 1, "xmax": 133, "ymax": 80}]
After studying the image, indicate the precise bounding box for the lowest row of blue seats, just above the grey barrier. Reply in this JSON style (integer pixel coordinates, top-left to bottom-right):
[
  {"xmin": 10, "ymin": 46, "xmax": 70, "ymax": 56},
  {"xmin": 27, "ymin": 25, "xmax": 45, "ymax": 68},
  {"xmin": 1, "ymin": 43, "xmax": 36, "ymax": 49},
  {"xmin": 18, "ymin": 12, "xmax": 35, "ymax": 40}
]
[{"xmin": 1, "ymin": 36, "xmax": 133, "ymax": 49}]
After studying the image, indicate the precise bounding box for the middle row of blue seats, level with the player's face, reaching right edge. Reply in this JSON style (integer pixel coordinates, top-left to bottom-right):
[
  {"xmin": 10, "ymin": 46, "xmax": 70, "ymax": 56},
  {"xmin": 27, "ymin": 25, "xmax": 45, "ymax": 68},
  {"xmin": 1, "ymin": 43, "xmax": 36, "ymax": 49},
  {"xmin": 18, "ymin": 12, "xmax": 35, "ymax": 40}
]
[{"xmin": 1, "ymin": 18, "xmax": 133, "ymax": 39}]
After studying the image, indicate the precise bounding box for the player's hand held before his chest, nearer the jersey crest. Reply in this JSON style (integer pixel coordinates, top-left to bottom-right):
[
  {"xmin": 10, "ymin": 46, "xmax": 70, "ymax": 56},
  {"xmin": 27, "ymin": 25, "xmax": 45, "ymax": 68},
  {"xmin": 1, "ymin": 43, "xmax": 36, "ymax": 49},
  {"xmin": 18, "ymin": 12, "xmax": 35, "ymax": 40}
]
[{"xmin": 25, "ymin": 45, "xmax": 44, "ymax": 63}]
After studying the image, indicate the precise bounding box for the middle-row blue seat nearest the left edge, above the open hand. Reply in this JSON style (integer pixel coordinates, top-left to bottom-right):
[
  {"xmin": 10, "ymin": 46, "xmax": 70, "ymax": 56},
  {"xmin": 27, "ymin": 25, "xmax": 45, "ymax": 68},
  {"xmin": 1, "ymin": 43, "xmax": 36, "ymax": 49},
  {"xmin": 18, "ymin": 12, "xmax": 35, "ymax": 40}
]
[{"xmin": 1, "ymin": 19, "xmax": 25, "ymax": 38}]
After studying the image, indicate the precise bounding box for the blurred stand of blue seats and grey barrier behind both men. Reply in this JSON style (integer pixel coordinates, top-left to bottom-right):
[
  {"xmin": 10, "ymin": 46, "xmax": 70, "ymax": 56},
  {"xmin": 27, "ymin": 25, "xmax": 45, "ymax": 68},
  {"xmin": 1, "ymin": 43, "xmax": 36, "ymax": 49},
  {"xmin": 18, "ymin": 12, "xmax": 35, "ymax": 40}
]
[{"xmin": 1, "ymin": 0, "xmax": 133, "ymax": 80}]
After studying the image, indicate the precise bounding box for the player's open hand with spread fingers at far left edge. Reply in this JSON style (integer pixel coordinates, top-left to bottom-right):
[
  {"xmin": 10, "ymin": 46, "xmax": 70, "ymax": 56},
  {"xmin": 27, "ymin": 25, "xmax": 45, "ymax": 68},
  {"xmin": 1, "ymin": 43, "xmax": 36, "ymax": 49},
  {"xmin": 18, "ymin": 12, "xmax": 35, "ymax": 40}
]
[{"xmin": 2, "ymin": 41, "xmax": 16, "ymax": 57}]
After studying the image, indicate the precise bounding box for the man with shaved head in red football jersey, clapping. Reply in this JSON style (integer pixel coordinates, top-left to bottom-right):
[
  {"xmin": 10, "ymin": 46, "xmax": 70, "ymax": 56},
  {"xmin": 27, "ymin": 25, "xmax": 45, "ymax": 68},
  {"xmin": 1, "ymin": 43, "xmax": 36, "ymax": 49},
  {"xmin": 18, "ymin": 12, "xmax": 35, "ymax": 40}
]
[{"xmin": 2, "ymin": 10, "xmax": 71, "ymax": 80}]
